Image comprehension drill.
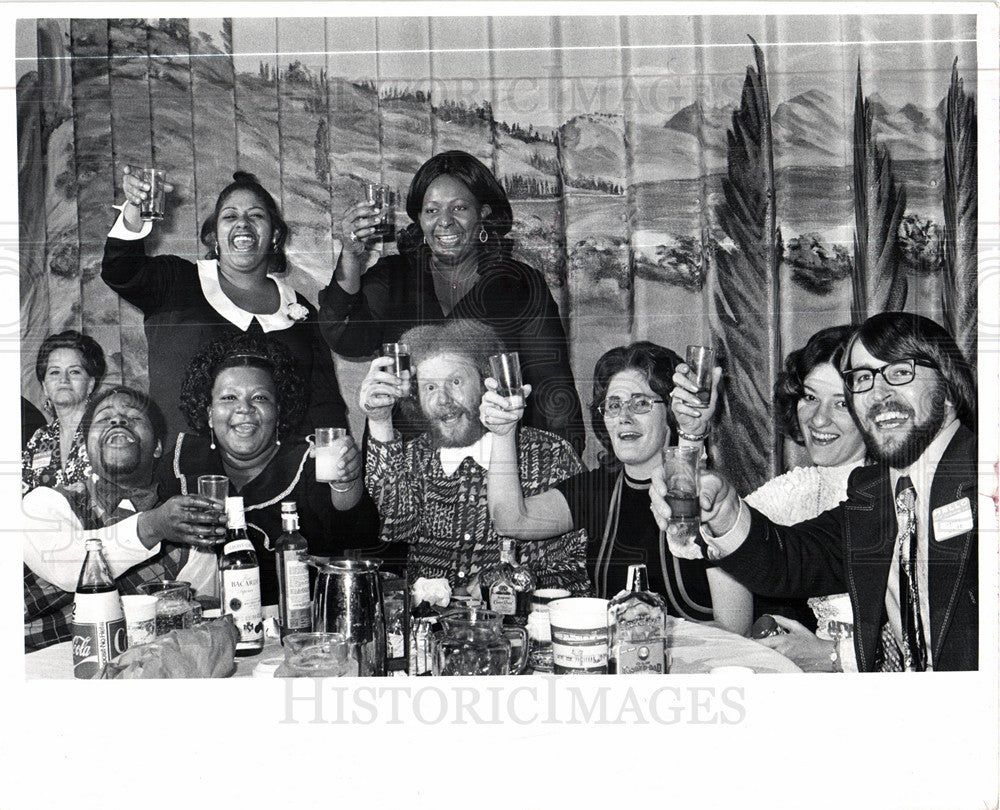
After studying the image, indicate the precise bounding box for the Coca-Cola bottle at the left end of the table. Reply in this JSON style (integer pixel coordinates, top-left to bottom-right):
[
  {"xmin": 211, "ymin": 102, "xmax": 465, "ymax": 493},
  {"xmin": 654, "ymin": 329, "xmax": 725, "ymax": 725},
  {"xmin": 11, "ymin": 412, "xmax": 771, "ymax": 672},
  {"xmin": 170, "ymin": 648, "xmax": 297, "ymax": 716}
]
[{"xmin": 71, "ymin": 540, "xmax": 128, "ymax": 678}]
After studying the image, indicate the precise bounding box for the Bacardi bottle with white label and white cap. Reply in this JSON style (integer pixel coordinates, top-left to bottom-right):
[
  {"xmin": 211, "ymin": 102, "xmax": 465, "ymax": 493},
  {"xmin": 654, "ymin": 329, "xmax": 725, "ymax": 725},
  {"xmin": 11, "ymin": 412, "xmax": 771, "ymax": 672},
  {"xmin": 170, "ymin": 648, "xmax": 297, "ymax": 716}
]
[{"xmin": 219, "ymin": 496, "xmax": 264, "ymax": 655}]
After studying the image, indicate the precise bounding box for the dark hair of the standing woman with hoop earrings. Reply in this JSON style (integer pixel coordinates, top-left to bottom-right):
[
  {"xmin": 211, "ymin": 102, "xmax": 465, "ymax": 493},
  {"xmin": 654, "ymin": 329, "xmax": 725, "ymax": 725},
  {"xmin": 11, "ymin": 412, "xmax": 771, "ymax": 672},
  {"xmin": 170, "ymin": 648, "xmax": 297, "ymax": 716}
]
[{"xmin": 400, "ymin": 149, "xmax": 514, "ymax": 252}]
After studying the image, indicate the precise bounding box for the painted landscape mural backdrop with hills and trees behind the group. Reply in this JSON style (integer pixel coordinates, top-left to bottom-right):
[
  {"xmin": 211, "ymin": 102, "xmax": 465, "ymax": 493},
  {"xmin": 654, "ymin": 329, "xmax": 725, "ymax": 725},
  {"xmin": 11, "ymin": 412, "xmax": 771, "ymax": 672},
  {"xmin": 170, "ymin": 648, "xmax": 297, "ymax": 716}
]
[{"xmin": 18, "ymin": 15, "xmax": 976, "ymax": 488}]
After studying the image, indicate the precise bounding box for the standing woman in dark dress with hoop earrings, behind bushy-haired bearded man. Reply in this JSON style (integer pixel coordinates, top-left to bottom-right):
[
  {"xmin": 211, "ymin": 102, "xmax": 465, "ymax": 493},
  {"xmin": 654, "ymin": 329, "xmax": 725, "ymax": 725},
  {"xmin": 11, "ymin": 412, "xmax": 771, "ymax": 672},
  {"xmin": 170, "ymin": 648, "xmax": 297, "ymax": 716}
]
[{"xmin": 319, "ymin": 150, "xmax": 585, "ymax": 452}]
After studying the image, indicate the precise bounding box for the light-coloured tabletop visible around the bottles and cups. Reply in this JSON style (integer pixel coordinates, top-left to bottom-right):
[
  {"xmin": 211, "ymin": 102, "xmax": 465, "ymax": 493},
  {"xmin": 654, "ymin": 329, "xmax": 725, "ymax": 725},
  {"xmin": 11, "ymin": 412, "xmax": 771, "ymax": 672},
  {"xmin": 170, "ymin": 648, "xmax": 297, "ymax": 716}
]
[{"xmin": 24, "ymin": 616, "xmax": 802, "ymax": 680}]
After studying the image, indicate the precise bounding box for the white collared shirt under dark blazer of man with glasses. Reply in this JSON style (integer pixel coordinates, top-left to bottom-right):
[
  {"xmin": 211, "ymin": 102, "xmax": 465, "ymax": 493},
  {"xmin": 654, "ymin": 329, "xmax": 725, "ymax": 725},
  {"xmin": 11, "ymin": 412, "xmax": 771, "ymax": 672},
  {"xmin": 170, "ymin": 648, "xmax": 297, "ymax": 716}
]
[{"xmin": 885, "ymin": 419, "xmax": 959, "ymax": 669}]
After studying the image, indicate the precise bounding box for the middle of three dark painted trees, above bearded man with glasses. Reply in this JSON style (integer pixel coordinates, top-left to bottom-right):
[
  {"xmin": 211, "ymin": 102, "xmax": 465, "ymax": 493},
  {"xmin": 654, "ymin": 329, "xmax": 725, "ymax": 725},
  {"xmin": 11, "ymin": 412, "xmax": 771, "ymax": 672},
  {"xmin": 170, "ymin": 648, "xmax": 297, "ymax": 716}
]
[{"xmin": 851, "ymin": 62, "xmax": 906, "ymax": 324}]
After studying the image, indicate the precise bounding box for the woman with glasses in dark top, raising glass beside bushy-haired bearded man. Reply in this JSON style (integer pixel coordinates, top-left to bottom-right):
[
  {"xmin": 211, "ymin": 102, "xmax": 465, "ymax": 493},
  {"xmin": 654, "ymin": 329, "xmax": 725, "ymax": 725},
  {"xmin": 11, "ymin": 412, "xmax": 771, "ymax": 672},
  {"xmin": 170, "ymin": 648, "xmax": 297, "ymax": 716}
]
[{"xmin": 480, "ymin": 341, "xmax": 752, "ymax": 634}]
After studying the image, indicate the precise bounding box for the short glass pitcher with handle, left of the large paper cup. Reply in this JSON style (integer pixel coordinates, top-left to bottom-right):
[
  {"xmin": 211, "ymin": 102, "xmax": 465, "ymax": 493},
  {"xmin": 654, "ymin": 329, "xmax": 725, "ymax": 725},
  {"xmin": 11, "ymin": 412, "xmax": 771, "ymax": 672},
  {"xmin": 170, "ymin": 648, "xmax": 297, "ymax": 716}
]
[{"xmin": 432, "ymin": 608, "xmax": 528, "ymax": 675}]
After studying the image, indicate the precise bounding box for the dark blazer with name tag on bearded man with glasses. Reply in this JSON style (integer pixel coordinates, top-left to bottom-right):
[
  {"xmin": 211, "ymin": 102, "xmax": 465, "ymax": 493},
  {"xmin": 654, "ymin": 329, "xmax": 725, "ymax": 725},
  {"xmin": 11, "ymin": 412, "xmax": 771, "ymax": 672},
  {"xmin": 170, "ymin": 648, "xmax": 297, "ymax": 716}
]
[{"xmin": 720, "ymin": 427, "xmax": 979, "ymax": 672}]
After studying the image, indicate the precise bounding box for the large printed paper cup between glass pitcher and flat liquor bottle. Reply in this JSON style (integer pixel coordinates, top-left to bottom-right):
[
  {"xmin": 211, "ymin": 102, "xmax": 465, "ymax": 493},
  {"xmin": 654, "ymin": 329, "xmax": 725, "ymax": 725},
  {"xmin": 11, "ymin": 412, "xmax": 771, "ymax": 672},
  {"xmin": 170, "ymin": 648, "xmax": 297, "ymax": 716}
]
[{"xmin": 549, "ymin": 597, "xmax": 608, "ymax": 675}]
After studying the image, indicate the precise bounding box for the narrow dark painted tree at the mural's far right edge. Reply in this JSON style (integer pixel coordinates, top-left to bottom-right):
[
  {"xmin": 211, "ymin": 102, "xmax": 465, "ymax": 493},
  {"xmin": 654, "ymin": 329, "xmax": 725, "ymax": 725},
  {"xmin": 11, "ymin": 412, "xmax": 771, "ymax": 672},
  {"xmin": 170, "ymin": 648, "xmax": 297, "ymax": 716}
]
[{"xmin": 941, "ymin": 59, "xmax": 979, "ymax": 363}]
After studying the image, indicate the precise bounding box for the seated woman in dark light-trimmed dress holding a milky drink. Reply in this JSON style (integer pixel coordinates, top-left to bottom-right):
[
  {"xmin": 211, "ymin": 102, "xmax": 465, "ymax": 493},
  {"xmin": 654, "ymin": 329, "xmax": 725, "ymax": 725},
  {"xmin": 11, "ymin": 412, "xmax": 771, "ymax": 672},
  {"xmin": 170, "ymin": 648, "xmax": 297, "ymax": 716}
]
[{"xmin": 158, "ymin": 335, "xmax": 379, "ymax": 605}]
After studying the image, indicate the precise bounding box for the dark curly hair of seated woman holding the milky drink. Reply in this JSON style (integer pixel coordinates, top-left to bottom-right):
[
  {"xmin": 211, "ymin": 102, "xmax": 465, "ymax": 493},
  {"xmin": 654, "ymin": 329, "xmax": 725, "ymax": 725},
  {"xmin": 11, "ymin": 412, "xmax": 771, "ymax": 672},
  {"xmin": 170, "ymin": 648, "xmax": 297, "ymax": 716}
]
[{"xmin": 181, "ymin": 332, "xmax": 308, "ymax": 439}]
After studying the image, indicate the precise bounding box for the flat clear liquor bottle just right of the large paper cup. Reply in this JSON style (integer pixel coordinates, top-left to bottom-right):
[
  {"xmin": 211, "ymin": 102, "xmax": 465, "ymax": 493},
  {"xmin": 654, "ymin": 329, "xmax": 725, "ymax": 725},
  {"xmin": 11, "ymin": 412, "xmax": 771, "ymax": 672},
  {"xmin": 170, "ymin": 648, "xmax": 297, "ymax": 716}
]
[{"xmin": 608, "ymin": 565, "xmax": 667, "ymax": 675}]
